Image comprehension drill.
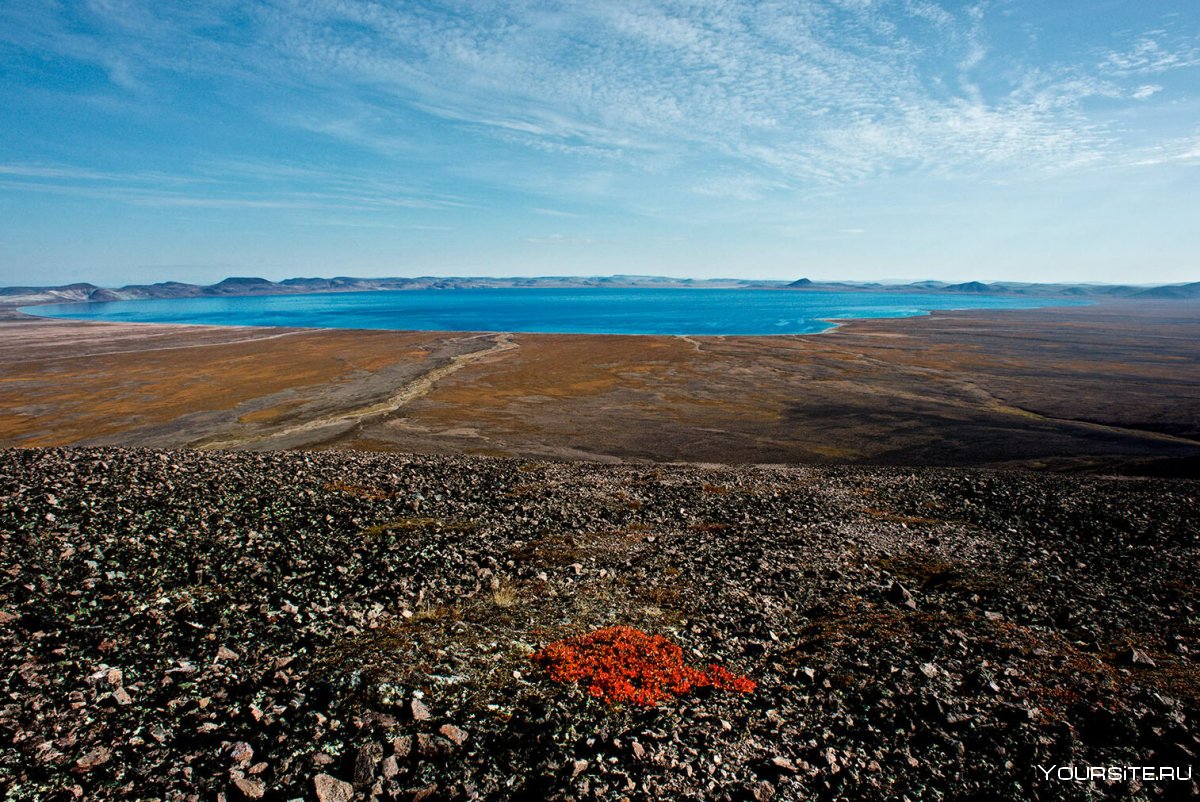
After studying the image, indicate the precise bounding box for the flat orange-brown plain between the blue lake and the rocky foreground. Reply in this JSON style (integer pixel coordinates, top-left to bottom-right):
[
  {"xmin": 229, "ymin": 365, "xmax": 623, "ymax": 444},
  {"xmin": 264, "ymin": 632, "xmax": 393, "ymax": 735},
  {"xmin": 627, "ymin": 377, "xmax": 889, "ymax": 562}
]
[{"xmin": 0, "ymin": 301, "xmax": 1200, "ymax": 475}]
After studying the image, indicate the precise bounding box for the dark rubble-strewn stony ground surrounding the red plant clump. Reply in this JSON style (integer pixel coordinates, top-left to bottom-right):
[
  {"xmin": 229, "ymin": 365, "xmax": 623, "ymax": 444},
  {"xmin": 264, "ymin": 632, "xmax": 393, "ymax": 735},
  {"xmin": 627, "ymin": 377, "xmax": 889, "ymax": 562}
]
[{"xmin": 0, "ymin": 449, "xmax": 1200, "ymax": 802}]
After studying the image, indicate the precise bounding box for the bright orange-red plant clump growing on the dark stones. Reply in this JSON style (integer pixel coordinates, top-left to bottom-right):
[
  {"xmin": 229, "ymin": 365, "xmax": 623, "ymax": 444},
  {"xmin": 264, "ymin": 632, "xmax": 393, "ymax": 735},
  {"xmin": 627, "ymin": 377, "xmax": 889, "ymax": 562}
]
[{"xmin": 532, "ymin": 627, "xmax": 755, "ymax": 707}]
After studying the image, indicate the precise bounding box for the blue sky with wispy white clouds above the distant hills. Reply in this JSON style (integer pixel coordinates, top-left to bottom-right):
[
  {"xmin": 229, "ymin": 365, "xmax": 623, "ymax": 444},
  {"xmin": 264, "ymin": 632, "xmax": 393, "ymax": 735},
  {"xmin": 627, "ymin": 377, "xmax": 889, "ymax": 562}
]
[{"xmin": 0, "ymin": 0, "xmax": 1200, "ymax": 286}]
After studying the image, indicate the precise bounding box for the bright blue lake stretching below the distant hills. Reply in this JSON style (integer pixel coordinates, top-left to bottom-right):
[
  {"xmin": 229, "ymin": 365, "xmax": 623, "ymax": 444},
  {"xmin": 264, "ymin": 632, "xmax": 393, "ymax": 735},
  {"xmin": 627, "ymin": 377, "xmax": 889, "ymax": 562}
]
[{"xmin": 25, "ymin": 287, "xmax": 1072, "ymax": 335}]
